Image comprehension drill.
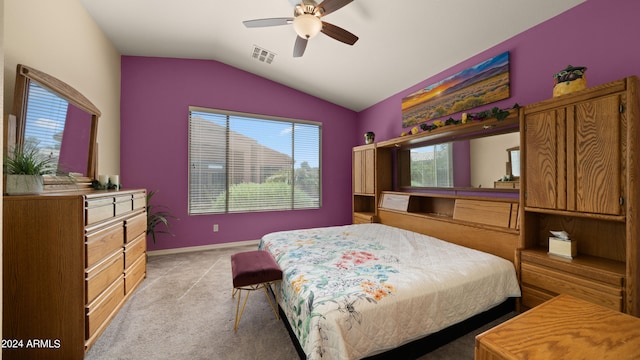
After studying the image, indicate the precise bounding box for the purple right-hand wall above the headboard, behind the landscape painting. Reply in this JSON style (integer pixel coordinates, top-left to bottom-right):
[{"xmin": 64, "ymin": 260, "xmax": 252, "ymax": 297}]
[{"xmin": 354, "ymin": 0, "xmax": 640, "ymax": 141}]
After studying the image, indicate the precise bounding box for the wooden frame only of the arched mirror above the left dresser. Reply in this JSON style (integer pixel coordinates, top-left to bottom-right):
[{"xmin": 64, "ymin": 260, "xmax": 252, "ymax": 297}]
[{"xmin": 9, "ymin": 64, "xmax": 102, "ymax": 187}]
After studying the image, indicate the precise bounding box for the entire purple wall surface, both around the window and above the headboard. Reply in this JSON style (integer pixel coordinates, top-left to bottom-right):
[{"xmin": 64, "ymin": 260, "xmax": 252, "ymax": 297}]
[{"xmin": 120, "ymin": 0, "xmax": 640, "ymax": 250}]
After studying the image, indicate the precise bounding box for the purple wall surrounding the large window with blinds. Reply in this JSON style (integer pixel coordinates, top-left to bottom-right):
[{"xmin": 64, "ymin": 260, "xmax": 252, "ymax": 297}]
[{"xmin": 121, "ymin": 56, "xmax": 360, "ymax": 250}]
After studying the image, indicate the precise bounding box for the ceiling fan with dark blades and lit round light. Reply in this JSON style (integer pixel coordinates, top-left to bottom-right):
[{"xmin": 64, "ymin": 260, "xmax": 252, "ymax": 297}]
[{"xmin": 242, "ymin": 0, "xmax": 358, "ymax": 57}]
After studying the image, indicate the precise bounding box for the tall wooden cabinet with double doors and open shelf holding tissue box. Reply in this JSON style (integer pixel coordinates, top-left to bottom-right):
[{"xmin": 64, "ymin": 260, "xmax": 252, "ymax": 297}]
[{"xmin": 520, "ymin": 77, "xmax": 640, "ymax": 316}]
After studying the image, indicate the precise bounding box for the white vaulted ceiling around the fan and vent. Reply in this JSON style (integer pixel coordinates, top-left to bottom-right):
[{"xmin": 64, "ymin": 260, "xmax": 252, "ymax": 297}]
[{"xmin": 80, "ymin": 0, "xmax": 585, "ymax": 111}]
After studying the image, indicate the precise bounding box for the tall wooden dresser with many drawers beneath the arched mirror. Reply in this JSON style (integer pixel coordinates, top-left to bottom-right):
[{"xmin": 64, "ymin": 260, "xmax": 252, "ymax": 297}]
[{"xmin": 2, "ymin": 190, "xmax": 147, "ymax": 359}]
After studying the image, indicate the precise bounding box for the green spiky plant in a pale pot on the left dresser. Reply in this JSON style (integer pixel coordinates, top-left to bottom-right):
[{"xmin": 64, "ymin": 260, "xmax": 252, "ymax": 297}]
[{"xmin": 3, "ymin": 142, "xmax": 56, "ymax": 195}]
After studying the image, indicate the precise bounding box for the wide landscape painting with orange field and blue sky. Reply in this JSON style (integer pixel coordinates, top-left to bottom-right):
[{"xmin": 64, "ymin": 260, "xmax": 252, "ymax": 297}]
[{"xmin": 402, "ymin": 51, "xmax": 510, "ymax": 128}]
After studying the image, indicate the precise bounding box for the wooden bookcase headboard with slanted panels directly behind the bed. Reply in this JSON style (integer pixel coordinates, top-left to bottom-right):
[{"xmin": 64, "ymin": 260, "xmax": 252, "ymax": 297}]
[{"xmin": 378, "ymin": 192, "xmax": 520, "ymax": 268}]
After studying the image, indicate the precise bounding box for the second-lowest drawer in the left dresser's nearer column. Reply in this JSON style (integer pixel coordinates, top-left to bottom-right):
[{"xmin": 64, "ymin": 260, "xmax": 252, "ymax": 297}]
[{"xmin": 85, "ymin": 250, "xmax": 124, "ymax": 304}]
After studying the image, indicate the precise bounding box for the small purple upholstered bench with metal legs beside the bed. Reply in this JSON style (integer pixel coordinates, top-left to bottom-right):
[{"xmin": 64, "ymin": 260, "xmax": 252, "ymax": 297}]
[{"xmin": 231, "ymin": 250, "xmax": 282, "ymax": 331}]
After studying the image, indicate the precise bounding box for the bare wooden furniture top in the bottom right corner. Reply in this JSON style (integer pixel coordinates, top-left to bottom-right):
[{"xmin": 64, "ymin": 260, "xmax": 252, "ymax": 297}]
[{"xmin": 475, "ymin": 295, "xmax": 640, "ymax": 360}]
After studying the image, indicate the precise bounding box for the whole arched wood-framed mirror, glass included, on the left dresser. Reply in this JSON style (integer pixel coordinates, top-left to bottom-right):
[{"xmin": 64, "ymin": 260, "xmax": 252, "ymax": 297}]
[{"xmin": 13, "ymin": 65, "xmax": 101, "ymax": 190}]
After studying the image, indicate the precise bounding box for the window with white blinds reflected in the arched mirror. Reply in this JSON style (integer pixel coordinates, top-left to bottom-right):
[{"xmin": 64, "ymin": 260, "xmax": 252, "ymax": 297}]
[{"xmin": 24, "ymin": 81, "xmax": 69, "ymax": 168}]
